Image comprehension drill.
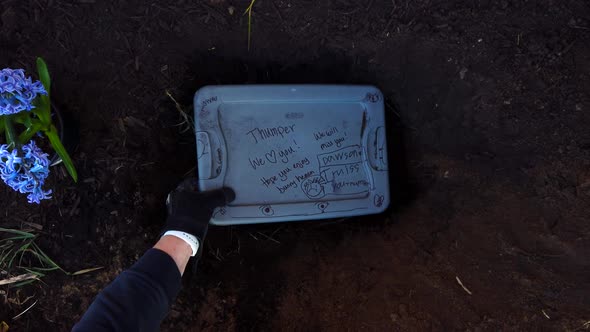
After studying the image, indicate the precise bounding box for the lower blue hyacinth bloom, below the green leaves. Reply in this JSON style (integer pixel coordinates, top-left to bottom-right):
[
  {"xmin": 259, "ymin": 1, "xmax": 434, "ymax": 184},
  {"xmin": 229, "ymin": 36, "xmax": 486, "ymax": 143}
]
[{"xmin": 0, "ymin": 140, "xmax": 51, "ymax": 204}]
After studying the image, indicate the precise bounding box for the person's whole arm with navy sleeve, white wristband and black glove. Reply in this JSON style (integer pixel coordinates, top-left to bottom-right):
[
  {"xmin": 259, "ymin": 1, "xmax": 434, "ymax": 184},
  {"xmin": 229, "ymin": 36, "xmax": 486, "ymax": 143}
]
[{"xmin": 73, "ymin": 185, "xmax": 233, "ymax": 331}]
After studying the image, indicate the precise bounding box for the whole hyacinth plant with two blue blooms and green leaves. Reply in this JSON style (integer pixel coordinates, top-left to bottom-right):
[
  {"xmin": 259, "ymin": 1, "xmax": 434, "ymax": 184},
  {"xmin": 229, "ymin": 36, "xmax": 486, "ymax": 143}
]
[{"xmin": 0, "ymin": 58, "xmax": 77, "ymax": 204}]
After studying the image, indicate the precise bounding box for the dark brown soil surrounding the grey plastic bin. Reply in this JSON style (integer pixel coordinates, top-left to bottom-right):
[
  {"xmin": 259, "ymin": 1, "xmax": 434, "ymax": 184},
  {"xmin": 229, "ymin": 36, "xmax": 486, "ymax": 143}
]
[{"xmin": 0, "ymin": 0, "xmax": 590, "ymax": 331}]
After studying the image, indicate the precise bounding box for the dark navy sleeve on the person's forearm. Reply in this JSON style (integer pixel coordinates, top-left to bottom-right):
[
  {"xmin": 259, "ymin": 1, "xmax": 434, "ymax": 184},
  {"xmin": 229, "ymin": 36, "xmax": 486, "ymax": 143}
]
[{"xmin": 72, "ymin": 248, "xmax": 181, "ymax": 331}]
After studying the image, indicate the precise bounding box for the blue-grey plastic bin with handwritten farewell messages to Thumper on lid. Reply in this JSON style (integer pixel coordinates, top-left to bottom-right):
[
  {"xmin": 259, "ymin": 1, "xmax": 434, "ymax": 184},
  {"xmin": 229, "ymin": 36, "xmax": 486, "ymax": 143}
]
[{"xmin": 194, "ymin": 85, "xmax": 389, "ymax": 225}]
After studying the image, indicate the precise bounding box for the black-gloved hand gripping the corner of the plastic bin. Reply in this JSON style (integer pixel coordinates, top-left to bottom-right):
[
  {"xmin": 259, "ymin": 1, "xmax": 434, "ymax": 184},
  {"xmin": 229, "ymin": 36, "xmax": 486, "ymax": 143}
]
[{"xmin": 162, "ymin": 178, "xmax": 236, "ymax": 252}]
